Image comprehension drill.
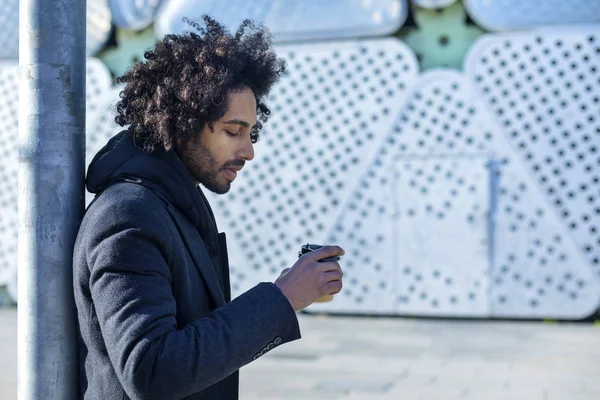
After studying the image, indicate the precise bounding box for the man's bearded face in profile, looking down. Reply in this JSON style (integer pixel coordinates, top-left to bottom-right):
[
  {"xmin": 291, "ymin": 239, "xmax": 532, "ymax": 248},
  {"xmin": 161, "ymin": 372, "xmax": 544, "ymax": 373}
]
[{"xmin": 180, "ymin": 89, "xmax": 256, "ymax": 194}]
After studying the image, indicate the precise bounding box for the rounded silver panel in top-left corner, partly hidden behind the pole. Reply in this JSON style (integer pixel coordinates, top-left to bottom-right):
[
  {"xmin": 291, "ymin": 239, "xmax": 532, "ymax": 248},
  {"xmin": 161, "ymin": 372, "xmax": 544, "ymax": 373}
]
[{"xmin": 0, "ymin": 0, "xmax": 111, "ymax": 60}]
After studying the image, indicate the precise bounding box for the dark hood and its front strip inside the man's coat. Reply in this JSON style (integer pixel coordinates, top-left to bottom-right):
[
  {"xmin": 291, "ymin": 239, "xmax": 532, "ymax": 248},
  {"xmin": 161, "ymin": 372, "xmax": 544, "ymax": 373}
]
[{"xmin": 86, "ymin": 131, "xmax": 226, "ymax": 306}]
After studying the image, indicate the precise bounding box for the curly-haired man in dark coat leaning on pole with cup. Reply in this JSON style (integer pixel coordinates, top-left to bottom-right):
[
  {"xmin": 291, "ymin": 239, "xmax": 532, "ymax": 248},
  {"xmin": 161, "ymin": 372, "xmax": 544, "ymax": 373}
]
[{"xmin": 74, "ymin": 17, "xmax": 343, "ymax": 400}]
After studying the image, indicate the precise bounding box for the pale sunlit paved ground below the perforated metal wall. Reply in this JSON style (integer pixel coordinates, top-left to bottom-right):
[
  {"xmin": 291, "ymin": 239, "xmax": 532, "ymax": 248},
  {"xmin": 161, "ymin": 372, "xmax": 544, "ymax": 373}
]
[{"xmin": 0, "ymin": 309, "xmax": 600, "ymax": 400}]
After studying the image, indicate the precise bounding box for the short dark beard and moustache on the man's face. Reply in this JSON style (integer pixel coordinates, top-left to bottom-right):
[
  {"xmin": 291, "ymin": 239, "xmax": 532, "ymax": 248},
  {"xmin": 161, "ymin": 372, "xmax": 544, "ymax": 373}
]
[{"xmin": 181, "ymin": 143, "xmax": 245, "ymax": 194}]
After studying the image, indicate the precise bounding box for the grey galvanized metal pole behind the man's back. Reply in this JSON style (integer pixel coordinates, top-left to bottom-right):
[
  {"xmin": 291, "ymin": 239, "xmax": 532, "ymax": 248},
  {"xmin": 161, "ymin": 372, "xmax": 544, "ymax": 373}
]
[{"xmin": 18, "ymin": 0, "xmax": 86, "ymax": 400}]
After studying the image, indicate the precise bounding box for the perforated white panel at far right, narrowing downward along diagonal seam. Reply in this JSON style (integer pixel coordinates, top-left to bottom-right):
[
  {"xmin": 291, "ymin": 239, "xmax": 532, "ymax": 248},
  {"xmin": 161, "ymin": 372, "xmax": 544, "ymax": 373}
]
[{"xmin": 465, "ymin": 26, "xmax": 600, "ymax": 286}]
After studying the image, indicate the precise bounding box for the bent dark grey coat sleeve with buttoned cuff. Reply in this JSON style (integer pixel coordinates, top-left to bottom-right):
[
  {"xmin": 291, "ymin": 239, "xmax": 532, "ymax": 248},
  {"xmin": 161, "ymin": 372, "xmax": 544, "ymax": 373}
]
[{"xmin": 86, "ymin": 188, "xmax": 300, "ymax": 400}]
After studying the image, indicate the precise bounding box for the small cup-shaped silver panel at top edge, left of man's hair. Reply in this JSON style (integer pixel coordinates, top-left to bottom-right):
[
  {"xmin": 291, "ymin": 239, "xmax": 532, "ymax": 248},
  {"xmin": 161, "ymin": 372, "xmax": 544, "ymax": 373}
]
[{"xmin": 109, "ymin": 0, "xmax": 162, "ymax": 31}]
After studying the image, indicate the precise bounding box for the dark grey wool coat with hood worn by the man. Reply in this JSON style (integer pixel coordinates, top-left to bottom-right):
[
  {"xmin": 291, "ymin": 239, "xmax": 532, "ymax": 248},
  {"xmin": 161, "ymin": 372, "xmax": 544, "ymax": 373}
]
[{"xmin": 73, "ymin": 132, "xmax": 300, "ymax": 400}]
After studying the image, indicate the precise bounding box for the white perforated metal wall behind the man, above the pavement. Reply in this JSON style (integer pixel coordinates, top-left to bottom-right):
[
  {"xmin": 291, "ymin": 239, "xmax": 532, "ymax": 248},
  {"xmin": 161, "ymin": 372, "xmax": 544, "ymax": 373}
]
[{"xmin": 0, "ymin": 18, "xmax": 600, "ymax": 318}]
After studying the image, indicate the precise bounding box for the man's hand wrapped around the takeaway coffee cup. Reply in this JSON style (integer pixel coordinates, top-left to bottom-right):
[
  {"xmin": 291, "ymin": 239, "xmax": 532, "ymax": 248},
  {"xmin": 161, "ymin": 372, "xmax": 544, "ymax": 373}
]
[{"xmin": 275, "ymin": 246, "xmax": 344, "ymax": 311}]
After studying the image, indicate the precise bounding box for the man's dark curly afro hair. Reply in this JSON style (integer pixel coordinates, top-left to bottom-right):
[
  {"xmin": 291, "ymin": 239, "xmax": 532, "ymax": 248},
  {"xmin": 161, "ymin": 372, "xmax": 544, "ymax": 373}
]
[{"xmin": 115, "ymin": 15, "xmax": 285, "ymax": 152}]
